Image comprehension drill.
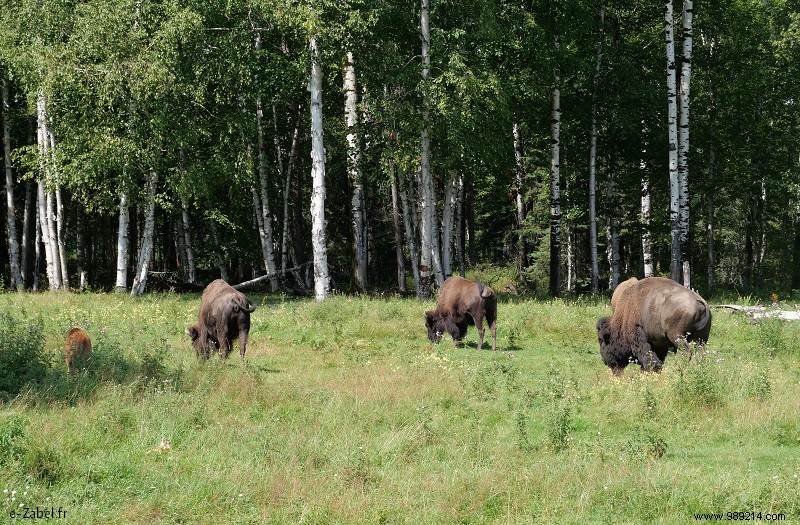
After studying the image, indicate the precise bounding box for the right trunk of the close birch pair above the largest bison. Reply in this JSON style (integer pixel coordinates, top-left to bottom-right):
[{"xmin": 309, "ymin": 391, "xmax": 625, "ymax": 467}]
[{"xmin": 678, "ymin": 0, "xmax": 693, "ymax": 287}]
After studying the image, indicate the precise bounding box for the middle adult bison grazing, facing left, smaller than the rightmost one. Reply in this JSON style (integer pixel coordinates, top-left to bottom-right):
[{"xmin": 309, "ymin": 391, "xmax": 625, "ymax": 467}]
[{"xmin": 425, "ymin": 275, "xmax": 497, "ymax": 350}]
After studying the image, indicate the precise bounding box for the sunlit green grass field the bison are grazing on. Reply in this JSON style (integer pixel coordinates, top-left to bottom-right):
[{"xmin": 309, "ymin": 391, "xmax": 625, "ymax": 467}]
[{"xmin": 0, "ymin": 293, "xmax": 800, "ymax": 524}]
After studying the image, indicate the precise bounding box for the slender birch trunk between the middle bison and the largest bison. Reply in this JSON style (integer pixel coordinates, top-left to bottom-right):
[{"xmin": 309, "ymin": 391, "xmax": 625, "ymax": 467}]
[{"xmin": 550, "ymin": 56, "xmax": 561, "ymax": 297}]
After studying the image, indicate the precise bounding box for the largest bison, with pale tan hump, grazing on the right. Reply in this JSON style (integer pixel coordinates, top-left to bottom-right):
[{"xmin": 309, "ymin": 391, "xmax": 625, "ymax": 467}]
[{"xmin": 597, "ymin": 277, "xmax": 711, "ymax": 375}]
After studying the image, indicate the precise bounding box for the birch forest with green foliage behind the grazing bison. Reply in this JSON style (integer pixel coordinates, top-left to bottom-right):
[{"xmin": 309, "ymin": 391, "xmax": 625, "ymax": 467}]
[{"xmin": 0, "ymin": 0, "xmax": 800, "ymax": 299}]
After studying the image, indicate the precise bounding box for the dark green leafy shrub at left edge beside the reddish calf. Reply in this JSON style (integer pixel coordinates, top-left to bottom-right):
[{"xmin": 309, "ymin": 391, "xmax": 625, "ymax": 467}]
[{"xmin": 0, "ymin": 313, "xmax": 49, "ymax": 400}]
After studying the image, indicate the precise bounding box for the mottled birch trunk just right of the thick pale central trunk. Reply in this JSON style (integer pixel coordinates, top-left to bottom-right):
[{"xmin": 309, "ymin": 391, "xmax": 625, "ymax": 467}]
[{"xmin": 343, "ymin": 51, "xmax": 367, "ymax": 292}]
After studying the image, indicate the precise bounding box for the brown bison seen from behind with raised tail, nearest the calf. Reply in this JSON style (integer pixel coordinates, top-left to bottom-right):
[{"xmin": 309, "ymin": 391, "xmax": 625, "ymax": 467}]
[{"xmin": 186, "ymin": 279, "xmax": 256, "ymax": 359}]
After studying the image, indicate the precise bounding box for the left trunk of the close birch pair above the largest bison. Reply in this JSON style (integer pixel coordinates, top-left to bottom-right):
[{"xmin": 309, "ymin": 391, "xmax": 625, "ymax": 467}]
[{"xmin": 664, "ymin": 0, "xmax": 682, "ymax": 282}]
